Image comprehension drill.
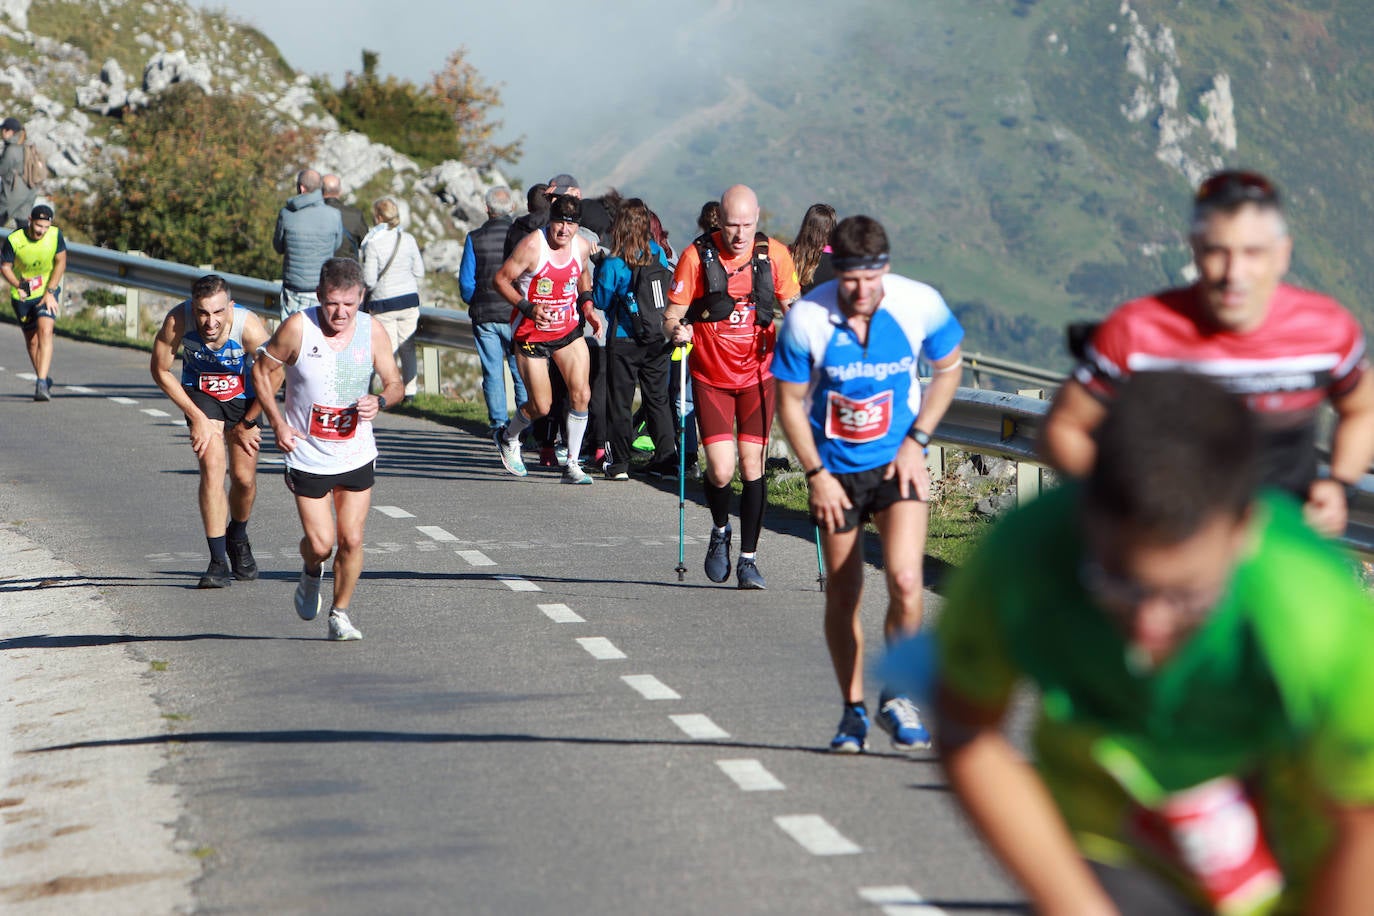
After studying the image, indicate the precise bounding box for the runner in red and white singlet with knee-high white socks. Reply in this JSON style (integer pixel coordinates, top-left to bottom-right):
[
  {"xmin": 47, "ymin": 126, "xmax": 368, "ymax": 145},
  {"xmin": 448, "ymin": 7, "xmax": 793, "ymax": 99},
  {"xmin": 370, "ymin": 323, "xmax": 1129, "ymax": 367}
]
[{"xmin": 492, "ymin": 195, "xmax": 600, "ymax": 483}]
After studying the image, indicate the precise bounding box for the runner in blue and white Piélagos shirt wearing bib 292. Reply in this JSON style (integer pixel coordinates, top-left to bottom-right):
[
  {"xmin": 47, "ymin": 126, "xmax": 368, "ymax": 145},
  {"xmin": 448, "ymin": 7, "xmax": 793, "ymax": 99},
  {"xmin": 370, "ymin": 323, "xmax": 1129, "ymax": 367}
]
[{"xmin": 774, "ymin": 216, "xmax": 963, "ymax": 754}]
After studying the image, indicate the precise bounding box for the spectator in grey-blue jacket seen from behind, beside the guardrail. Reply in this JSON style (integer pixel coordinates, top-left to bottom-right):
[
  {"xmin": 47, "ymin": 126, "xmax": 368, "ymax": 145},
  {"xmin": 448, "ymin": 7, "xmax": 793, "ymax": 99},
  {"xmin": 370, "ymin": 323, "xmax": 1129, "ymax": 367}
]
[{"xmin": 272, "ymin": 169, "xmax": 344, "ymax": 321}]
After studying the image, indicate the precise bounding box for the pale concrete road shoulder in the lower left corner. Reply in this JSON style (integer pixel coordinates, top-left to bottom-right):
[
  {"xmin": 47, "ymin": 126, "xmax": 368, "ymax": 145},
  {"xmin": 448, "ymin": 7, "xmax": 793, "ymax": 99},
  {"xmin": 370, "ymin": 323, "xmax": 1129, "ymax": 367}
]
[{"xmin": 0, "ymin": 525, "xmax": 201, "ymax": 913}]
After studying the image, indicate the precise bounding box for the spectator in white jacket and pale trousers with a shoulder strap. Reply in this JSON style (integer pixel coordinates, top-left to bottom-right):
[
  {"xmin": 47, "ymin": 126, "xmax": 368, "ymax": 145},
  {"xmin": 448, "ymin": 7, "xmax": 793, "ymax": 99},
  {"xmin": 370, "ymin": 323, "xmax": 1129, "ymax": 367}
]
[{"xmin": 363, "ymin": 198, "xmax": 425, "ymax": 405}]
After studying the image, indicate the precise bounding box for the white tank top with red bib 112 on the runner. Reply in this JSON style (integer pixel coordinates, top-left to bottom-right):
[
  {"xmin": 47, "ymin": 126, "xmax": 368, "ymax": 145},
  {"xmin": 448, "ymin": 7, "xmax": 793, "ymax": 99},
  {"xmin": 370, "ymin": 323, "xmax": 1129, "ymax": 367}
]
[{"xmin": 286, "ymin": 308, "xmax": 376, "ymax": 474}]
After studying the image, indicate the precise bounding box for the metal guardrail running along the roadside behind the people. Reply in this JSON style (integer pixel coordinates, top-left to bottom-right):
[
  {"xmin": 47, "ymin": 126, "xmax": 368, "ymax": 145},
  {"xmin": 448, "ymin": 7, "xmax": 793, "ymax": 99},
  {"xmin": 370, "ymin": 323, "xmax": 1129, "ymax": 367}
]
[{"xmin": 67, "ymin": 243, "xmax": 1374, "ymax": 553}]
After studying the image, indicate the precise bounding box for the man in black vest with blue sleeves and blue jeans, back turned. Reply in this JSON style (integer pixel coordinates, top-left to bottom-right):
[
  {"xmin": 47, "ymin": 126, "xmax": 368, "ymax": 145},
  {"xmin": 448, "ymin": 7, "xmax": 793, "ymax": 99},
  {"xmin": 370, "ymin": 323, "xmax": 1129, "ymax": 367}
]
[{"xmin": 458, "ymin": 187, "xmax": 529, "ymax": 430}]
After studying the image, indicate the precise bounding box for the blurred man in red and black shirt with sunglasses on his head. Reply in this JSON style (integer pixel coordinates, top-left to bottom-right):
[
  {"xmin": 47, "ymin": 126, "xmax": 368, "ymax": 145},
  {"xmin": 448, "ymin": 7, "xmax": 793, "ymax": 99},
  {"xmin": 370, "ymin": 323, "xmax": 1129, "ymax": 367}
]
[{"xmin": 1041, "ymin": 170, "xmax": 1374, "ymax": 537}]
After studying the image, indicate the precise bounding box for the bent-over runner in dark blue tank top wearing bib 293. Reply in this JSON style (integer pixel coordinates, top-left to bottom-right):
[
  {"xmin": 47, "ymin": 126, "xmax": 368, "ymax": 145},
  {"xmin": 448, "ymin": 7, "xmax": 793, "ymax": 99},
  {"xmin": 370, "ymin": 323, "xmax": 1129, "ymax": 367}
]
[{"xmin": 150, "ymin": 273, "xmax": 268, "ymax": 588}]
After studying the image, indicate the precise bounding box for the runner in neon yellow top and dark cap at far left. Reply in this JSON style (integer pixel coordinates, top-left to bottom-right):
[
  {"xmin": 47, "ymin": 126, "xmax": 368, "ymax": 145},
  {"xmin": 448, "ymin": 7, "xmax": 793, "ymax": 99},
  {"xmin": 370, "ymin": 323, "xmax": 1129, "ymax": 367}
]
[{"xmin": 0, "ymin": 203, "xmax": 67, "ymax": 401}]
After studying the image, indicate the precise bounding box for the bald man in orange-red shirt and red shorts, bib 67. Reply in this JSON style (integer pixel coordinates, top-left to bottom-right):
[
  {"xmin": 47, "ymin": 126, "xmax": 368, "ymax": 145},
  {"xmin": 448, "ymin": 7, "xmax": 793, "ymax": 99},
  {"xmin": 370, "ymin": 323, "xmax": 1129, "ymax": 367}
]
[{"xmin": 664, "ymin": 184, "xmax": 801, "ymax": 589}]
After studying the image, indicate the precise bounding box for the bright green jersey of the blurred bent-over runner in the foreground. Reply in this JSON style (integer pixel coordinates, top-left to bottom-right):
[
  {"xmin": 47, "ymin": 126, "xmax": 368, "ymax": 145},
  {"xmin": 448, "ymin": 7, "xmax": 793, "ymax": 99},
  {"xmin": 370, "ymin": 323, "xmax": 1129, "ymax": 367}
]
[{"xmin": 938, "ymin": 485, "xmax": 1374, "ymax": 911}]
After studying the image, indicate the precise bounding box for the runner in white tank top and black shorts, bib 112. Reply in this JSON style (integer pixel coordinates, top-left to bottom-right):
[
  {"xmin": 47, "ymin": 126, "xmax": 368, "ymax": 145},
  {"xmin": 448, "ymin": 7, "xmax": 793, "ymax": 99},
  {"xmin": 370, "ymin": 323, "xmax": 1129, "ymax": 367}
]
[{"xmin": 253, "ymin": 258, "xmax": 405, "ymax": 640}]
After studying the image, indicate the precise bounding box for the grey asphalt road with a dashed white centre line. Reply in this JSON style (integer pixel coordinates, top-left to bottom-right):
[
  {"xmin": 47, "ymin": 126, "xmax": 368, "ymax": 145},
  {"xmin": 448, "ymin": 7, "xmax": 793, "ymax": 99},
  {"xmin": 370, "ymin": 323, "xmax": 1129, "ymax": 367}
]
[{"xmin": 0, "ymin": 325, "xmax": 1020, "ymax": 913}]
